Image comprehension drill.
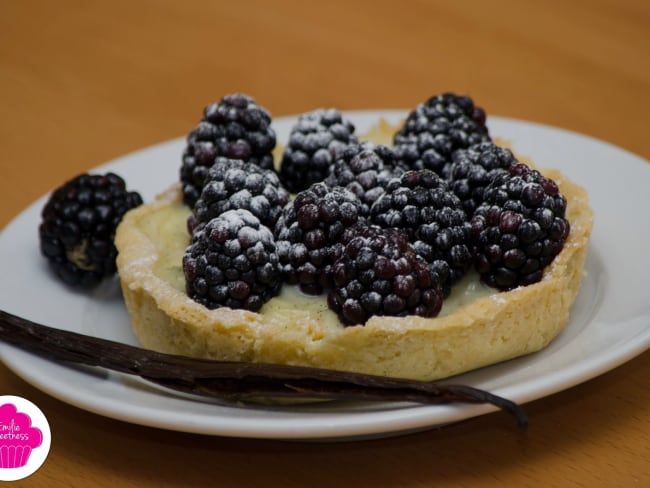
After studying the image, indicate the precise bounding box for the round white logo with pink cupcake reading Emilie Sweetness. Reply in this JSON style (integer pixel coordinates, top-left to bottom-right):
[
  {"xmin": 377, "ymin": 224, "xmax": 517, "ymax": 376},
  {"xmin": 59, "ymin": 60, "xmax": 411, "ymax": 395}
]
[{"xmin": 0, "ymin": 395, "xmax": 51, "ymax": 481}]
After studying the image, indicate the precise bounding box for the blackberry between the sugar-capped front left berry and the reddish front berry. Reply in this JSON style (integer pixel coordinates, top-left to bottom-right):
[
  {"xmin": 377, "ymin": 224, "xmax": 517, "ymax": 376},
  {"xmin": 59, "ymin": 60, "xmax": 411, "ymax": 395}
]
[{"xmin": 275, "ymin": 182, "xmax": 363, "ymax": 295}]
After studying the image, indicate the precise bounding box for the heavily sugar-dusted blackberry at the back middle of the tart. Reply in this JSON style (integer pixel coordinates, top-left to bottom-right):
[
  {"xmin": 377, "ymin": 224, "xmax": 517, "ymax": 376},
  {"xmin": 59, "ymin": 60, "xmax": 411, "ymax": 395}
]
[{"xmin": 280, "ymin": 109, "xmax": 357, "ymax": 193}]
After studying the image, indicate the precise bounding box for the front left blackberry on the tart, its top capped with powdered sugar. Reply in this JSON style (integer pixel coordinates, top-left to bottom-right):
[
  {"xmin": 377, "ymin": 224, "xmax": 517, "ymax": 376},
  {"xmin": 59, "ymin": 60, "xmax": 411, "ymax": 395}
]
[{"xmin": 183, "ymin": 209, "xmax": 281, "ymax": 311}]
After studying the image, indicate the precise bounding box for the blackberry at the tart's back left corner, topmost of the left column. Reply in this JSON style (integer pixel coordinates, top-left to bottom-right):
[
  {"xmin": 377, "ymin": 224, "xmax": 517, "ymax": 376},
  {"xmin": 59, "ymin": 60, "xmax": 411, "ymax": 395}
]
[{"xmin": 180, "ymin": 93, "xmax": 276, "ymax": 207}]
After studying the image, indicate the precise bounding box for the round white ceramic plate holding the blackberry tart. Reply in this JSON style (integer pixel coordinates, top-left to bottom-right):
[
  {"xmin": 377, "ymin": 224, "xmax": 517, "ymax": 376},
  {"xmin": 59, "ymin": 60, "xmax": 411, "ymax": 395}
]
[{"xmin": 0, "ymin": 111, "xmax": 650, "ymax": 439}]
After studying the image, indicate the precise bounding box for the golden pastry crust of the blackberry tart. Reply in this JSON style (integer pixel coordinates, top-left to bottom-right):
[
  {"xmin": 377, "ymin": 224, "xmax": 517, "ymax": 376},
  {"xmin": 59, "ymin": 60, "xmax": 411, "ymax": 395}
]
[{"xmin": 116, "ymin": 126, "xmax": 592, "ymax": 380}]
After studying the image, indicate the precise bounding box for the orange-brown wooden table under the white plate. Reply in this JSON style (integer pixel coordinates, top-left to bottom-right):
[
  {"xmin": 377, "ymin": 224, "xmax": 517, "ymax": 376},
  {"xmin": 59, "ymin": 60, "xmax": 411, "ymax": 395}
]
[{"xmin": 0, "ymin": 0, "xmax": 650, "ymax": 488}]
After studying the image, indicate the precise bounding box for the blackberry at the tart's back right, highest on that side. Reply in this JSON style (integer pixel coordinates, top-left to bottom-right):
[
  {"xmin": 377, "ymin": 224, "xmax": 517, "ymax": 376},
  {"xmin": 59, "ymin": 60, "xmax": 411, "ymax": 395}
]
[{"xmin": 393, "ymin": 93, "xmax": 490, "ymax": 176}]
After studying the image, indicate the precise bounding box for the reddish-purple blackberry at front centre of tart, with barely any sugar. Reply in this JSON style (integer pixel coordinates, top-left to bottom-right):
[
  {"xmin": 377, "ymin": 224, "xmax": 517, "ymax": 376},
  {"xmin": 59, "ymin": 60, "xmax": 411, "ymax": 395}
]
[{"xmin": 327, "ymin": 226, "xmax": 443, "ymax": 325}]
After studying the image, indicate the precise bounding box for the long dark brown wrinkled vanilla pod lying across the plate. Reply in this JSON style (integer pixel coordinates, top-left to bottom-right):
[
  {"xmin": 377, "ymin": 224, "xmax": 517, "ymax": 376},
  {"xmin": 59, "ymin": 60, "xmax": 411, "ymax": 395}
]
[{"xmin": 0, "ymin": 310, "xmax": 528, "ymax": 429}]
